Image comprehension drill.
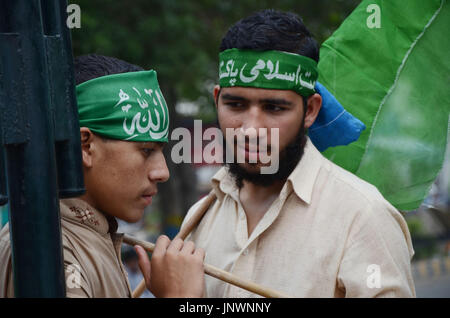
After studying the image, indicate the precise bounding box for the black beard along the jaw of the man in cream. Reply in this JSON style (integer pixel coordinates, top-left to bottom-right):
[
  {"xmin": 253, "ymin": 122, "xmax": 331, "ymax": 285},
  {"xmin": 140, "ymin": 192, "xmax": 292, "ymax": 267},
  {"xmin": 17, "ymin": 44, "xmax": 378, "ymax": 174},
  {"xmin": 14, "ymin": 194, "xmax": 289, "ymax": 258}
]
[{"xmin": 223, "ymin": 120, "xmax": 306, "ymax": 189}]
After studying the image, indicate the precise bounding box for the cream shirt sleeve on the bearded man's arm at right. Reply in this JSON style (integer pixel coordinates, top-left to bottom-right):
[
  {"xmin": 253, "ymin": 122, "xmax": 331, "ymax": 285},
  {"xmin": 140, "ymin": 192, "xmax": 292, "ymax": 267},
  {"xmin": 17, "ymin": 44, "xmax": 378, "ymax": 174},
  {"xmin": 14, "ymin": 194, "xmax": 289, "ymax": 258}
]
[{"xmin": 338, "ymin": 202, "xmax": 416, "ymax": 298}]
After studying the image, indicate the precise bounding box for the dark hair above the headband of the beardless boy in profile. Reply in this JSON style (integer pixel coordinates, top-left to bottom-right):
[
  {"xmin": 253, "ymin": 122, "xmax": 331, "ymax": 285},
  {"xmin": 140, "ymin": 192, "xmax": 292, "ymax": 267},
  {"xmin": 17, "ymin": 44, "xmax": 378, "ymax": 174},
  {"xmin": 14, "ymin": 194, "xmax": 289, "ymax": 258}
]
[{"xmin": 74, "ymin": 54, "xmax": 144, "ymax": 85}]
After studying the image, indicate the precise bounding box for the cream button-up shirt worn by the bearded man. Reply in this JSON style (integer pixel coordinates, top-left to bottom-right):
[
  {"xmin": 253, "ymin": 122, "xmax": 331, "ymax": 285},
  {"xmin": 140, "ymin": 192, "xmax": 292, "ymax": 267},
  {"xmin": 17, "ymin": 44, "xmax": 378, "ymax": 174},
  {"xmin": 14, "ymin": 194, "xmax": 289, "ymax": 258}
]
[{"xmin": 183, "ymin": 139, "xmax": 415, "ymax": 297}]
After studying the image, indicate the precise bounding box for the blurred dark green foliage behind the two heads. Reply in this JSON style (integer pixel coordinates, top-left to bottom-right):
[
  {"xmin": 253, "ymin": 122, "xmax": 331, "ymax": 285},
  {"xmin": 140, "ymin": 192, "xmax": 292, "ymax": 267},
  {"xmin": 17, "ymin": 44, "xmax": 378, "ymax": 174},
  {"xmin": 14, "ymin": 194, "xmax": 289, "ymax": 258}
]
[{"xmin": 71, "ymin": 0, "xmax": 359, "ymax": 120}]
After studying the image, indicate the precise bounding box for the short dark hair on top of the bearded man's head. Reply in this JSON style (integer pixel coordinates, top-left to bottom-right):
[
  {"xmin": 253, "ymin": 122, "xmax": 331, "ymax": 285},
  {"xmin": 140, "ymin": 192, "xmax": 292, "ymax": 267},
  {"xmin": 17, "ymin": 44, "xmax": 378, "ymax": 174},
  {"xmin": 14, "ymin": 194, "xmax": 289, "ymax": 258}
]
[{"xmin": 220, "ymin": 9, "xmax": 319, "ymax": 62}]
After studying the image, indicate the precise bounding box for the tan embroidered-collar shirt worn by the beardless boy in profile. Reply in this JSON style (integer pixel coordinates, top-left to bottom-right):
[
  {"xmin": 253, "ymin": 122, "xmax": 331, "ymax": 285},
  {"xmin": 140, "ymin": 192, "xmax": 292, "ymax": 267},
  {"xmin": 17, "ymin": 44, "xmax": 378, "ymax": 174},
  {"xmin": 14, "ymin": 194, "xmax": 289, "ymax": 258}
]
[{"xmin": 0, "ymin": 199, "xmax": 131, "ymax": 298}]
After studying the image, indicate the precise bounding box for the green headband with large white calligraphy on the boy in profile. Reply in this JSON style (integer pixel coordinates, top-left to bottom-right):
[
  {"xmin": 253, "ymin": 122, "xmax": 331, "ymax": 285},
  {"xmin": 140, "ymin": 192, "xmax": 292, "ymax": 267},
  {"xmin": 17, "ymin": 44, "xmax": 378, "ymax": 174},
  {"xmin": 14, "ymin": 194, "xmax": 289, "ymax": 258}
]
[{"xmin": 77, "ymin": 70, "xmax": 169, "ymax": 142}]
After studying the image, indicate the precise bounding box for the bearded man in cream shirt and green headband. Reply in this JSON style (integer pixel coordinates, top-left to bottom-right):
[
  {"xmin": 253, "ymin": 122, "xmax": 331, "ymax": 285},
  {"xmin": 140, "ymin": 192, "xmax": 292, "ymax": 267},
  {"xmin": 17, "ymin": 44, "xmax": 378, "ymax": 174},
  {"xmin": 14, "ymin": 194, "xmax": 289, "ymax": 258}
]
[{"xmin": 176, "ymin": 10, "xmax": 415, "ymax": 297}]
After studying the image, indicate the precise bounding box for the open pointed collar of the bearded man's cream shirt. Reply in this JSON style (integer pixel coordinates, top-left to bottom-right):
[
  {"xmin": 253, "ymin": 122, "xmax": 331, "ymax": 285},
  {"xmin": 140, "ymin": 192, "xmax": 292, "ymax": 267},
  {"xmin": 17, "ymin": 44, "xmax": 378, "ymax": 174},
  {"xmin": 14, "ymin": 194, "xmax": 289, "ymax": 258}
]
[{"xmin": 211, "ymin": 137, "xmax": 323, "ymax": 204}]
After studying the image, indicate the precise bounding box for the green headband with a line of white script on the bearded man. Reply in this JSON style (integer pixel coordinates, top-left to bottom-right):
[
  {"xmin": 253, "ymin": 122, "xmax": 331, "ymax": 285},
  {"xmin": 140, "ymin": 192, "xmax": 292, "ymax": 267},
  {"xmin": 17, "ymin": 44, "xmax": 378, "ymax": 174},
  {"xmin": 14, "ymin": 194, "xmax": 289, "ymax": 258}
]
[{"xmin": 219, "ymin": 49, "xmax": 319, "ymax": 97}]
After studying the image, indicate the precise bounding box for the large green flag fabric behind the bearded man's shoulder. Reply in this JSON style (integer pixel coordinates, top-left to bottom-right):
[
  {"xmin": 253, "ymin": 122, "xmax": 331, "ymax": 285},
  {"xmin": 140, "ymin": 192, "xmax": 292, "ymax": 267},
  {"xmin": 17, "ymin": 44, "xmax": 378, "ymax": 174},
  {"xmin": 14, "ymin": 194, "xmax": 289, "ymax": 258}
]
[{"xmin": 318, "ymin": 0, "xmax": 450, "ymax": 210}]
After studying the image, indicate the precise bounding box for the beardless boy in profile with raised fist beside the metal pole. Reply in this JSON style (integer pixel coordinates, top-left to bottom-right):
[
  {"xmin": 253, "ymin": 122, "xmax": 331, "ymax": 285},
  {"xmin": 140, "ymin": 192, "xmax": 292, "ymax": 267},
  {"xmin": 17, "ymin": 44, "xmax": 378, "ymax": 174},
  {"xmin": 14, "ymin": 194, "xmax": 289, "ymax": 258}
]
[{"xmin": 0, "ymin": 54, "xmax": 204, "ymax": 298}]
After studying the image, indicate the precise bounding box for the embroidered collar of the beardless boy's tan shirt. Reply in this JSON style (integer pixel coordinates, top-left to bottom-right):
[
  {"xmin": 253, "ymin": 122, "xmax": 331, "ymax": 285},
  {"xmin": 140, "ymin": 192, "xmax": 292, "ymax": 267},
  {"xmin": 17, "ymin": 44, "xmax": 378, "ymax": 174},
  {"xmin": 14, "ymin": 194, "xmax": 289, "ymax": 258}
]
[{"xmin": 60, "ymin": 198, "xmax": 118, "ymax": 235}]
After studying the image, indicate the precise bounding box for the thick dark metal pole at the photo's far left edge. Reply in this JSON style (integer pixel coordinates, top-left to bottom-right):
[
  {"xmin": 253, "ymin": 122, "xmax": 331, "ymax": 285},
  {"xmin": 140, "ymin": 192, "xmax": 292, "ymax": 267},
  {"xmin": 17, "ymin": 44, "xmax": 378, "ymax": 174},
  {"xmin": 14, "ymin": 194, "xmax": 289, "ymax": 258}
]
[{"xmin": 0, "ymin": 0, "xmax": 65, "ymax": 297}]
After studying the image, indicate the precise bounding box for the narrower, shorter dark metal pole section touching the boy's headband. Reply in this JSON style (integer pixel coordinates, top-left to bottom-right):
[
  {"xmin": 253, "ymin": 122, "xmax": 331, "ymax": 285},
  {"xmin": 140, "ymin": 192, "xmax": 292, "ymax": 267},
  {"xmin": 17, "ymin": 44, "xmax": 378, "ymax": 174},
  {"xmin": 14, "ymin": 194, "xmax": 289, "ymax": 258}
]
[{"xmin": 41, "ymin": 0, "xmax": 85, "ymax": 198}]
